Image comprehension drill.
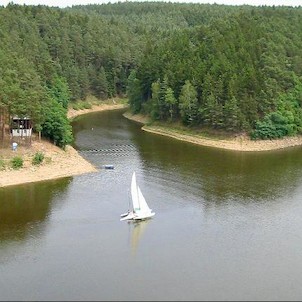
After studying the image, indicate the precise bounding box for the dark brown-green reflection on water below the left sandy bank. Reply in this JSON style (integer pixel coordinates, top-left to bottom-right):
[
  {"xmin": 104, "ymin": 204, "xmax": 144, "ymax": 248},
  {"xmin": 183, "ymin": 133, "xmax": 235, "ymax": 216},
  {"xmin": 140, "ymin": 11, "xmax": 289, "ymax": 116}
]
[{"xmin": 0, "ymin": 178, "xmax": 70, "ymax": 243}]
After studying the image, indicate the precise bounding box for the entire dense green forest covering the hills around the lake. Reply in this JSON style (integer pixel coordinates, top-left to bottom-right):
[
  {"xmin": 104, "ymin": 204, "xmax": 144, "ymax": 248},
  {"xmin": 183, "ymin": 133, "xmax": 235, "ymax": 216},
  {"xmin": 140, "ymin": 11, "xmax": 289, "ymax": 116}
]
[{"xmin": 0, "ymin": 2, "xmax": 302, "ymax": 147}]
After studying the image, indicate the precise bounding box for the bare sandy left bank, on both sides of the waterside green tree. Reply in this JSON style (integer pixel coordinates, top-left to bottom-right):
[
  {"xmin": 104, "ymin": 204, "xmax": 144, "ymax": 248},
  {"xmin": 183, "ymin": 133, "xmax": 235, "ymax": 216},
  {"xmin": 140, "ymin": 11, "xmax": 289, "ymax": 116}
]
[{"xmin": 0, "ymin": 104, "xmax": 125, "ymax": 188}]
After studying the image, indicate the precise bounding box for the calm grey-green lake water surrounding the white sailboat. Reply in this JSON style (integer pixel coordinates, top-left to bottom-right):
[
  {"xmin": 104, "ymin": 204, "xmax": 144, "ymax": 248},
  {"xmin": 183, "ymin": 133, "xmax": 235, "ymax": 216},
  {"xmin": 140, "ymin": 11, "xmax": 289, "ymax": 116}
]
[{"xmin": 0, "ymin": 111, "xmax": 302, "ymax": 301}]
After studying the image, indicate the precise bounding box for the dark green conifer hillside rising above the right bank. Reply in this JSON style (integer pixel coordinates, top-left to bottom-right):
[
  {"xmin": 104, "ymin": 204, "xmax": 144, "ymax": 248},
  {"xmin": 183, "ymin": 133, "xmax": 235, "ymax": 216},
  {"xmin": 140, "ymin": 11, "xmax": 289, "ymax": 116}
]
[{"xmin": 124, "ymin": 6, "xmax": 302, "ymax": 137}]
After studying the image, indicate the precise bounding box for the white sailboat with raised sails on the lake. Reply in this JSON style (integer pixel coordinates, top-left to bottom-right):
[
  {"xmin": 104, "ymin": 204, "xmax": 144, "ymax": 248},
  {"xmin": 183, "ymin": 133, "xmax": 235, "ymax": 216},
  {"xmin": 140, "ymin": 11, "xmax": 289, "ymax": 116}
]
[{"xmin": 120, "ymin": 172, "xmax": 155, "ymax": 221}]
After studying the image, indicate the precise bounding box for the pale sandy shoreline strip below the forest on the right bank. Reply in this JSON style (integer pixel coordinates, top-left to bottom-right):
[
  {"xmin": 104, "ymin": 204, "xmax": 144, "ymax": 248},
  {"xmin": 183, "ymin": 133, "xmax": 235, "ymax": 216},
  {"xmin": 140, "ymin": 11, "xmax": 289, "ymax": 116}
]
[{"xmin": 124, "ymin": 112, "xmax": 302, "ymax": 152}]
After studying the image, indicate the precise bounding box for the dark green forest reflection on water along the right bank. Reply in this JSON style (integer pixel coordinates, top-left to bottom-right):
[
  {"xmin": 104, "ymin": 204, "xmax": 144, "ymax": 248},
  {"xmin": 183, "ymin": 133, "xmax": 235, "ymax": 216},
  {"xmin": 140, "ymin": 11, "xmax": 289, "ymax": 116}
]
[{"xmin": 133, "ymin": 126, "xmax": 302, "ymax": 205}]
